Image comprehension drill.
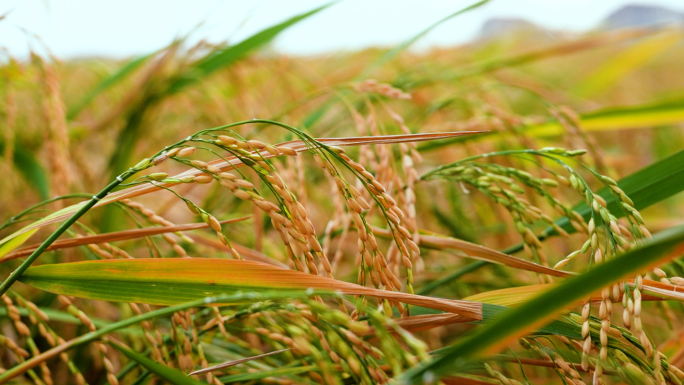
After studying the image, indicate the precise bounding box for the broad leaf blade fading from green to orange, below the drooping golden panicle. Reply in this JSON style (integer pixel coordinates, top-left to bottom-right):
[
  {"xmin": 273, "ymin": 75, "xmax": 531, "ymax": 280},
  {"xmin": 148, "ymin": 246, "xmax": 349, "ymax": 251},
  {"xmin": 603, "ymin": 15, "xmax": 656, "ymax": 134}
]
[{"xmin": 20, "ymin": 258, "xmax": 482, "ymax": 320}]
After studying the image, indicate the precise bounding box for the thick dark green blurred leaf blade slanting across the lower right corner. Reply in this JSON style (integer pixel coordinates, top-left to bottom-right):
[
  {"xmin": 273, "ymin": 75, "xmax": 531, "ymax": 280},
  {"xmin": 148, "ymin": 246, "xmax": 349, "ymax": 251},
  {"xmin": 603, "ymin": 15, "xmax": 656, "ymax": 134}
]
[{"xmin": 400, "ymin": 226, "xmax": 684, "ymax": 383}]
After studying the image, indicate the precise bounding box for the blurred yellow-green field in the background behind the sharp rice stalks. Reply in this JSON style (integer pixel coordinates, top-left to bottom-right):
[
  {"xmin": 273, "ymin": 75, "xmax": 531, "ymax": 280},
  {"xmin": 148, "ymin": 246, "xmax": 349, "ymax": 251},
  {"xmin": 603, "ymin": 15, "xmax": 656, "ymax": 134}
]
[{"xmin": 0, "ymin": 1, "xmax": 684, "ymax": 240}]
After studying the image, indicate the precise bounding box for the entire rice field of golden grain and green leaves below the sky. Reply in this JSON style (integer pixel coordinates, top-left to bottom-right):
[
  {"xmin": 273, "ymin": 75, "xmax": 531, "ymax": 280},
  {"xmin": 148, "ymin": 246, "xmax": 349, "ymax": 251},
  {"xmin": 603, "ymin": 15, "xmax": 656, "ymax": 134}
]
[{"xmin": 0, "ymin": 3, "xmax": 684, "ymax": 385}]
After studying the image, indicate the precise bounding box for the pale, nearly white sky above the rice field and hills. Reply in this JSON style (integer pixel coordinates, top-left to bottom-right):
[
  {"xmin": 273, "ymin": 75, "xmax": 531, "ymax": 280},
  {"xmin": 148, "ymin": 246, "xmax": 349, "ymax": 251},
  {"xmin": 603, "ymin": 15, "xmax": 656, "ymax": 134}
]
[{"xmin": 0, "ymin": 0, "xmax": 684, "ymax": 58}]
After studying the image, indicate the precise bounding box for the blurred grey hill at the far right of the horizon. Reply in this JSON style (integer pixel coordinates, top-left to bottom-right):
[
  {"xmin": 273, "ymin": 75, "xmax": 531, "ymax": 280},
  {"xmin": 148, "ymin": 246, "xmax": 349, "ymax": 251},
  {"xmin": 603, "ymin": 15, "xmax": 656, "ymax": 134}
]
[{"xmin": 600, "ymin": 4, "xmax": 684, "ymax": 30}]
